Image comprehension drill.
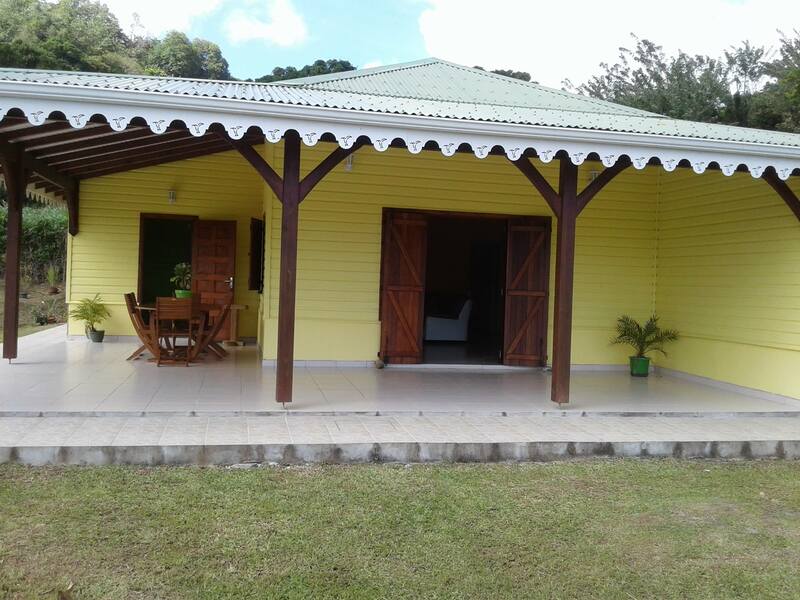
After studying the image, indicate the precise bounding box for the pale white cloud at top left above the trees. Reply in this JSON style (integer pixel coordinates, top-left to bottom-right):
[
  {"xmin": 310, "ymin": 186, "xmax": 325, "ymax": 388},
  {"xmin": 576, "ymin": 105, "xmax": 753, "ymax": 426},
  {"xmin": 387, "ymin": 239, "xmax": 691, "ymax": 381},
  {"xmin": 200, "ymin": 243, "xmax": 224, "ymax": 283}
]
[{"xmin": 103, "ymin": 0, "xmax": 225, "ymax": 35}]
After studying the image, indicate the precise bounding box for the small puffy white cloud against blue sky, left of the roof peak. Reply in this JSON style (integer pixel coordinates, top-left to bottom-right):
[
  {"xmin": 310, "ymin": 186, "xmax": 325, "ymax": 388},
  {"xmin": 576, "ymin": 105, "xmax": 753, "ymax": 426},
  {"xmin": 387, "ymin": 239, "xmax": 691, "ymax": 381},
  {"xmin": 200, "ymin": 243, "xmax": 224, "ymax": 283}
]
[{"xmin": 225, "ymin": 0, "xmax": 308, "ymax": 47}]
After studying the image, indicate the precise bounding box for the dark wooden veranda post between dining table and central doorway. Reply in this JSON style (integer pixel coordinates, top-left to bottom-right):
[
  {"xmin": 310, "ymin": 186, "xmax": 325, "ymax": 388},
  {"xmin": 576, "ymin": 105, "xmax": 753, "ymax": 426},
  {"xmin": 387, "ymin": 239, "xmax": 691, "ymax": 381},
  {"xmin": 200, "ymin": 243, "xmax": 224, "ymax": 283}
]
[{"xmin": 275, "ymin": 131, "xmax": 300, "ymax": 403}]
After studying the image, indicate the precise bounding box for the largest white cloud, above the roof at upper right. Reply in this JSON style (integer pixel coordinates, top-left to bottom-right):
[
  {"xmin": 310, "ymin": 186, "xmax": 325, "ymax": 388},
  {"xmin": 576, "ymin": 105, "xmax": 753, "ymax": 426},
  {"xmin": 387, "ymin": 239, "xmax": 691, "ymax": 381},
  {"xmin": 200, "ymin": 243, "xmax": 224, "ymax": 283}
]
[{"xmin": 419, "ymin": 0, "xmax": 800, "ymax": 87}]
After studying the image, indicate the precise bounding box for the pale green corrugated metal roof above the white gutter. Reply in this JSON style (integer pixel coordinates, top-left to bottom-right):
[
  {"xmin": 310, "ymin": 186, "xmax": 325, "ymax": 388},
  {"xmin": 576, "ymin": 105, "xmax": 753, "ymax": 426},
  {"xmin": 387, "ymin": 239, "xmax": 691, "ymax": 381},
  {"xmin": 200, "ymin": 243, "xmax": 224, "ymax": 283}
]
[{"xmin": 0, "ymin": 58, "xmax": 800, "ymax": 147}]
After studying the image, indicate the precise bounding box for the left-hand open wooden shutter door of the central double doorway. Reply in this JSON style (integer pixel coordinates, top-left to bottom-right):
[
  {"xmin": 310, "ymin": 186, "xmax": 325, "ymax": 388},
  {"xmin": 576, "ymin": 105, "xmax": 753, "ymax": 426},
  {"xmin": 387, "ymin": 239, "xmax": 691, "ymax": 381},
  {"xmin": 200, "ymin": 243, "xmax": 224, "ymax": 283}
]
[{"xmin": 380, "ymin": 211, "xmax": 428, "ymax": 364}]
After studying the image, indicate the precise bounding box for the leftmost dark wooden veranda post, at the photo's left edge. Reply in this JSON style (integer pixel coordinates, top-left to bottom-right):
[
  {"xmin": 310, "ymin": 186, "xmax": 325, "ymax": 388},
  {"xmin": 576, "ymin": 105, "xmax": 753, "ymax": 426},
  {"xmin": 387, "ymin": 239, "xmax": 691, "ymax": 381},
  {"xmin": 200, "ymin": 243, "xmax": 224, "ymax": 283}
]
[{"xmin": 0, "ymin": 147, "xmax": 30, "ymax": 362}]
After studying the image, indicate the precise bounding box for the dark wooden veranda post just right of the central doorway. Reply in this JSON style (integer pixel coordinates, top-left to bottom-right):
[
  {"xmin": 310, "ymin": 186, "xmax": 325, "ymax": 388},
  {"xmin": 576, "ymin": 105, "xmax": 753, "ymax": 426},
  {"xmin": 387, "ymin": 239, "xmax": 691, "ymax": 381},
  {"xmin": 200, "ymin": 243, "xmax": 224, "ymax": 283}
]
[{"xmin": 550, "ymin": 157, "xmax": 578, "ymax": 404}]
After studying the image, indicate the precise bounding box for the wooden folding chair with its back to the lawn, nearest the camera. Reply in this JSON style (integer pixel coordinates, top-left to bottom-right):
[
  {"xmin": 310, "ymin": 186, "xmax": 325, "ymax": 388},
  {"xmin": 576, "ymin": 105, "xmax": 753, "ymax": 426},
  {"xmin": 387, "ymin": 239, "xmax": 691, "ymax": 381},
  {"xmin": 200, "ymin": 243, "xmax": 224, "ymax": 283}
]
[{"xmin": 153, "ymin": 297, "xmax": 205, "ymax": 367}]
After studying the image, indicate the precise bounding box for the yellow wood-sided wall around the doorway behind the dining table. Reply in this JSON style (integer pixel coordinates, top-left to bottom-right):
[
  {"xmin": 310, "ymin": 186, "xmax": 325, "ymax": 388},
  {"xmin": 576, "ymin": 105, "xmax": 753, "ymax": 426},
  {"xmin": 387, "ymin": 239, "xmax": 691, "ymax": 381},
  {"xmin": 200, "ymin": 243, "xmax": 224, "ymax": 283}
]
[{"xmin": 67, "ymin": 152, "xmax": 263, "ymax": 336}]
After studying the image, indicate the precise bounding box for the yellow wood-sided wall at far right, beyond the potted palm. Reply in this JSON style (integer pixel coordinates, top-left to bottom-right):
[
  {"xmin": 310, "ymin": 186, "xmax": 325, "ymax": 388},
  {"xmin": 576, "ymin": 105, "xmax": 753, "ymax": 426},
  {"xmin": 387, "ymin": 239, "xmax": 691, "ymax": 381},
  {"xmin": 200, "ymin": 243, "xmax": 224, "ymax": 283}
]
[{"xmin": 656, "ymin": 170, "xmax": 800, "ymax": 396}]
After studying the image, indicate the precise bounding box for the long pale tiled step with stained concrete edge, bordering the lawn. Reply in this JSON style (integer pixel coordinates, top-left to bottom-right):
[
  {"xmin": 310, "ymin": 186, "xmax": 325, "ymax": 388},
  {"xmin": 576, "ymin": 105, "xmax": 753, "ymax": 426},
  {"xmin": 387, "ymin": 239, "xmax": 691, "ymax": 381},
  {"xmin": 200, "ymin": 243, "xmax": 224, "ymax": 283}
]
[{"xmin": 0, "ymin": 415, "xmax": 800, "ymax": 464}]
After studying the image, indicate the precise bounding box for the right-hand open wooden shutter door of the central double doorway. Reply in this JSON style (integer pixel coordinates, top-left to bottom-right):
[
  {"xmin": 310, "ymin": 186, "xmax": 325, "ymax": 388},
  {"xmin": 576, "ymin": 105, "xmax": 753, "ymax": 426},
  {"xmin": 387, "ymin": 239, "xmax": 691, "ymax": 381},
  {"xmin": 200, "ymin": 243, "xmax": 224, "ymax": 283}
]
[{"xmin": 503, "ymin": 217, "xmax": 550, "ymax": 367}]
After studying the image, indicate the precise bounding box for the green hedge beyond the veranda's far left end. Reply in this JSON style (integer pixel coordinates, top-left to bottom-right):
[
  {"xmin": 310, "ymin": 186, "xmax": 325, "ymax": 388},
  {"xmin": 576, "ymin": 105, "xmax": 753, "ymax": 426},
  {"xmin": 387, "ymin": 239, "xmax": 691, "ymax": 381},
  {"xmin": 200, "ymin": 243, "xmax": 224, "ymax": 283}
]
[{"xmin": 0, "ymin": 206, "xmax": 69, "ymax": 283}]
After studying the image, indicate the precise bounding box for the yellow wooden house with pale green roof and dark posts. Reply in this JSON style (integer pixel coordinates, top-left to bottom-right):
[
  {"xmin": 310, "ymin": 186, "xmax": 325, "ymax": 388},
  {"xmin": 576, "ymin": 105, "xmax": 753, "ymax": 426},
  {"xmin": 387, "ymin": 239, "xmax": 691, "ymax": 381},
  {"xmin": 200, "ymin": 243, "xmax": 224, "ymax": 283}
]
[{"xmin": 0, "ymin": 59, "xmax": 800, "ymax": 403}]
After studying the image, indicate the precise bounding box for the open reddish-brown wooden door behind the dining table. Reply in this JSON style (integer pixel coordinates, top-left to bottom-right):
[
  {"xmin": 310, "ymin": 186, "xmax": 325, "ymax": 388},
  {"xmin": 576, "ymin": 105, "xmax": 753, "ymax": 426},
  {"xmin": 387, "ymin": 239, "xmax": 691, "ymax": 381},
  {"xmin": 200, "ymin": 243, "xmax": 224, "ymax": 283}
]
[{"xmin": 192, "ymin": 221, "xmax": 236, "ymax": 340}]
